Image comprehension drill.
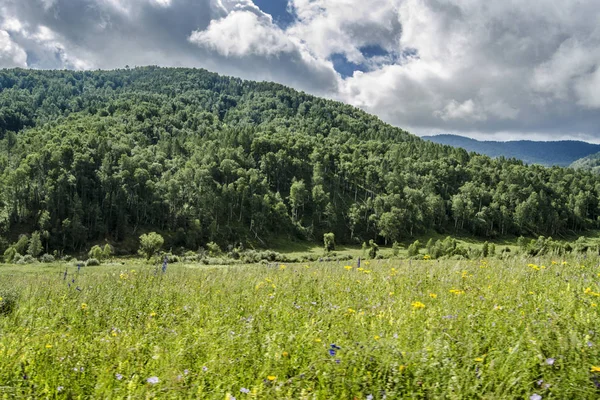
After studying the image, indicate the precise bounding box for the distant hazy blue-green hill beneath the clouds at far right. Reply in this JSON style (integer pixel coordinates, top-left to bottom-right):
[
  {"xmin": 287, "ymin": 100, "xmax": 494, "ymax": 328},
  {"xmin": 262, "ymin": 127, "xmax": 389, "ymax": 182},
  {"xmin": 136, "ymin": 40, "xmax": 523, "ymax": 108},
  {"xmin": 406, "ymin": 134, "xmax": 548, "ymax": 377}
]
[{"xmin": 423, "ymin": 135, "xmax": 600, "ymax": 167}]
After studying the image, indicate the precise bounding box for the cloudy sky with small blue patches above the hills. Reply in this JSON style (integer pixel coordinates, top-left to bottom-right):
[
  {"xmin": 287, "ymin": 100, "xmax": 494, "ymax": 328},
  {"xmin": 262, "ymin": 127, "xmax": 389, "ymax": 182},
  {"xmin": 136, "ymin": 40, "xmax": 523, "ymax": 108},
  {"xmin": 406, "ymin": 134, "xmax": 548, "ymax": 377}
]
[{"xmin": 0, "ymin": 0, "xmax": 600, "ymax": 143}]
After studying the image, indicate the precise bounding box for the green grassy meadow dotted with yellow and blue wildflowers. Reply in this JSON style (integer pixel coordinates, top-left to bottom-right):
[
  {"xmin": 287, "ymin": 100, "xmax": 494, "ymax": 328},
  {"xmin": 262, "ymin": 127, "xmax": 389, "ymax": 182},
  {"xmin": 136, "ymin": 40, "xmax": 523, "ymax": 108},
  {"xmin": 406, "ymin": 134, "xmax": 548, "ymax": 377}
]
[{"xmin": 0, "ymin": 257, "xmax": 600, "ymax": 399}]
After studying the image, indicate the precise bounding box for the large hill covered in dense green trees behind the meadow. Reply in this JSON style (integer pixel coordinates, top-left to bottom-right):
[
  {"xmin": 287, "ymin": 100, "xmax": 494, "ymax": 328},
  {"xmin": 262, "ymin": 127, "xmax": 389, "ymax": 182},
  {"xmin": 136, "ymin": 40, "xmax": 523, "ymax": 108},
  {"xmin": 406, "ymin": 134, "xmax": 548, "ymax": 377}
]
[{"xmin": 0, "ymin": 68, "xmax": 600, "ymax": 251}]
